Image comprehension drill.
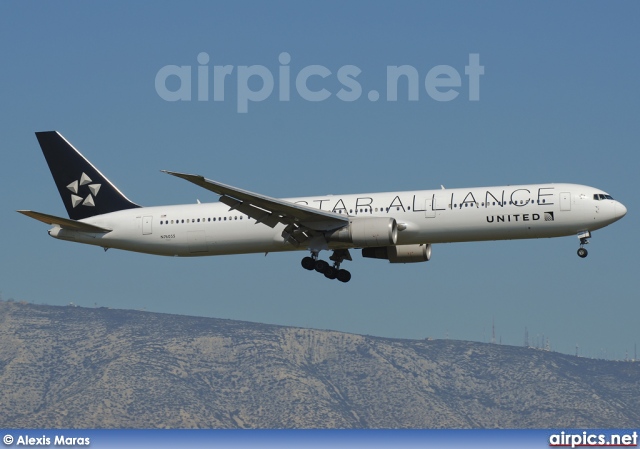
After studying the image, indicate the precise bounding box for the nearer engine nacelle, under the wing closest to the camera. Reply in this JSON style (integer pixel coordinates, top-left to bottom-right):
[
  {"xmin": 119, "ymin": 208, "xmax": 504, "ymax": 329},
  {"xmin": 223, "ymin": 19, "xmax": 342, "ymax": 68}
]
[{"xmin": 327, "ymin": 217, "xmax": 398, "ymax": 248}]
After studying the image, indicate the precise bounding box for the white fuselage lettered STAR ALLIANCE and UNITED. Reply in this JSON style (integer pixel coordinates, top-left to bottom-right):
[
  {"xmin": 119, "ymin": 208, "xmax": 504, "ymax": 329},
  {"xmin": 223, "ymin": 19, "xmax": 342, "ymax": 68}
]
[{"xmin": 49, "ymin": 184, "xmax": 626, "ymax": 256}]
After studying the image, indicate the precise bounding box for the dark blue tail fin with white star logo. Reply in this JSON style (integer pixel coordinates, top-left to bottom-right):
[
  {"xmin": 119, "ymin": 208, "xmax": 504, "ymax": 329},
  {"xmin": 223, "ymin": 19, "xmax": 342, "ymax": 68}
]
[{"xmin": 36, "ymin": 131, "xmax": 140, "ymax": 220}]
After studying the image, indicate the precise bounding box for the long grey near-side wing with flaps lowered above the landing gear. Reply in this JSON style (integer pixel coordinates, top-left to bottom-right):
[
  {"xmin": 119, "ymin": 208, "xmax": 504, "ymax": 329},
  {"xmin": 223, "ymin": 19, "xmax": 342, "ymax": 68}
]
[{"xmin": 162, "ymin": 170, "xmax": 349, "ymax": 236}]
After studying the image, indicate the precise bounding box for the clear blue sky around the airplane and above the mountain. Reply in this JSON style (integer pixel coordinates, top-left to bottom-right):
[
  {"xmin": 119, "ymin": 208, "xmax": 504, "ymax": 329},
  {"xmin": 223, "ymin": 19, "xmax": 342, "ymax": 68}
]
[{"xmin": 0, "ymin": 2, "xmax": 640, "ymax": 358}]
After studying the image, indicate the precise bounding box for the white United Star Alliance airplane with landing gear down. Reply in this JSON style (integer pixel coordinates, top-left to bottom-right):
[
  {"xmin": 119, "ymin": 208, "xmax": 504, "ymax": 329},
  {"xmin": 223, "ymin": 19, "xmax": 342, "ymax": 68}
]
[{"xmin": 17, "ymin": 131, "xmax": 627, "ymax": 282}]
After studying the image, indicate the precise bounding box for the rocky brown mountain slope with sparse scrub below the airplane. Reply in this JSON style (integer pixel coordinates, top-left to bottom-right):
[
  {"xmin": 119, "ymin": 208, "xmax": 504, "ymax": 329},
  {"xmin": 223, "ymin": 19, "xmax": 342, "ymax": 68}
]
[{"xmin": 0, "ymin": 302, "xmax": 640, "ymax": 428}]
